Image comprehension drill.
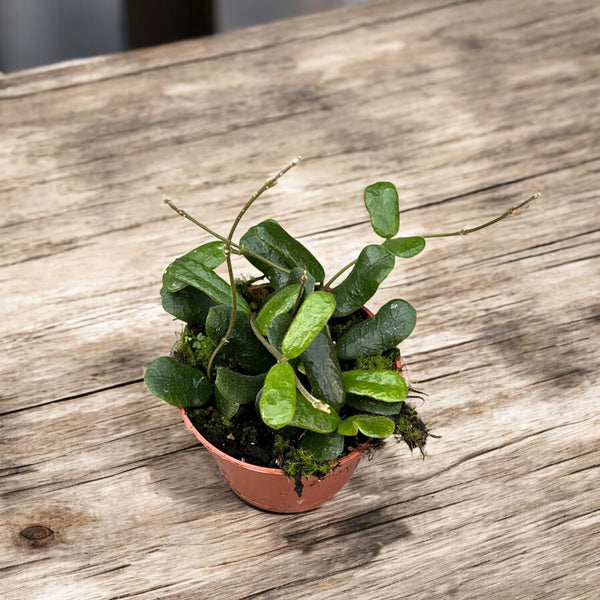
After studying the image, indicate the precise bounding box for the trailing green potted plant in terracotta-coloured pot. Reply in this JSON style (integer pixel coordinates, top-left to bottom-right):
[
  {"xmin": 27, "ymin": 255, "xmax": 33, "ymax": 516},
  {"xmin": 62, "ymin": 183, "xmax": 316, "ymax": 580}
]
[{"xmin": 144, "ymin": 158, "xmax": 535, "ymax": 512}]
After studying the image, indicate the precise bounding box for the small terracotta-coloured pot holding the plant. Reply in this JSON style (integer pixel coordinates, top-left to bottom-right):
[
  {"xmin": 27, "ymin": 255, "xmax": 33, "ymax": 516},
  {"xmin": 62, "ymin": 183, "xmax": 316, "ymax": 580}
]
[{"xmin": 179, "ymin": 408, "xmax": 365, "ymax": 513}]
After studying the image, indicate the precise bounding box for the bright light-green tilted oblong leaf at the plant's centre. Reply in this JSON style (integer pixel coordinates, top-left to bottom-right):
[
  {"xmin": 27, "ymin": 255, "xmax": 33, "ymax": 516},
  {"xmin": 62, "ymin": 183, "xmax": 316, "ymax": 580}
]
[{"xmin": 281, "ymin": 292, "xmax": 335, "ymax": 358}]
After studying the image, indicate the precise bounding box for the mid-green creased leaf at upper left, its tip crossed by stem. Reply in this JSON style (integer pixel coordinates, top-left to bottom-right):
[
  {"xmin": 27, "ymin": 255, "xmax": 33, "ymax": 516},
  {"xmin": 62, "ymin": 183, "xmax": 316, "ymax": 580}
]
[{"xmin": 163, "ymin": 257, "xmax": 250, "ymax": 315}]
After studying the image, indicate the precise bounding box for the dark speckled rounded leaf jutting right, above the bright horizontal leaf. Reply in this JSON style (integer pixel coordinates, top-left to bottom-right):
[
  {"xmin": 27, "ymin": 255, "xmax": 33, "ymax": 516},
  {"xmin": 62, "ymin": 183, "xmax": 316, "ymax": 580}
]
[{"xmin": 335, "ymin": 300, "xmax": 417, "ymax": 360}]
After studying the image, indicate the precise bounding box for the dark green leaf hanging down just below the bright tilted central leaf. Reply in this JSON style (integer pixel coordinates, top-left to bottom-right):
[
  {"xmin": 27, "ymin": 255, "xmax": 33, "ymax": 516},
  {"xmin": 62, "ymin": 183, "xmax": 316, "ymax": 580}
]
[{"xmin": 302, "ymin": 329, "xmax": 346, "ymax": 410}]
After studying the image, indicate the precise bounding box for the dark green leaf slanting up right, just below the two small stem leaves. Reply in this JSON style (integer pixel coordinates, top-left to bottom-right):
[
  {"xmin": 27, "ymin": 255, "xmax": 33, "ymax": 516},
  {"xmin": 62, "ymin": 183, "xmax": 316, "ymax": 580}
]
[{"xmin": 331, "ymin": 245, "xmax": 396, "ymax": 317}]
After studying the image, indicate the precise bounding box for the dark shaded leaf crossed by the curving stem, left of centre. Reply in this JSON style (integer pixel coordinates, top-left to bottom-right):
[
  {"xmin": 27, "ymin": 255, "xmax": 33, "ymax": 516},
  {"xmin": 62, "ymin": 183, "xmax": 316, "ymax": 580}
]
[{"xmin": 206, "ymin": 305, "xmax": 275, "ymax": 375}]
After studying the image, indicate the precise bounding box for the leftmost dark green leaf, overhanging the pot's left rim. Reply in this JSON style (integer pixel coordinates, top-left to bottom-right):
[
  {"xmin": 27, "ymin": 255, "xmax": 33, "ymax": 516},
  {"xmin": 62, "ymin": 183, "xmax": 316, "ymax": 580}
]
[{"xmin": 144, "ymin": 356, "xmax": 212, "ymax": 408}]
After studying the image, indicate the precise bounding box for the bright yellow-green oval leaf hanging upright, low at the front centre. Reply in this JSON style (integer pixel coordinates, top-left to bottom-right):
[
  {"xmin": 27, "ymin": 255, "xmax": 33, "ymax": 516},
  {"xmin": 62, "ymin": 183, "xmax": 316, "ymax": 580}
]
[{"xmin": 258, "ymin": 362, "xmax": 296, "ymax": 429}]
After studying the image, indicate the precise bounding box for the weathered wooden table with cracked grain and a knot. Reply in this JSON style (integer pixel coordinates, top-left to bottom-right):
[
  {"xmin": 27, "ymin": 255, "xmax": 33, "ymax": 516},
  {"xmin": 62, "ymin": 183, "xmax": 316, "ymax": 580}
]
[{"xmin": 0, "ymin": 0, "xmax": 600, "ymax": 600}]
